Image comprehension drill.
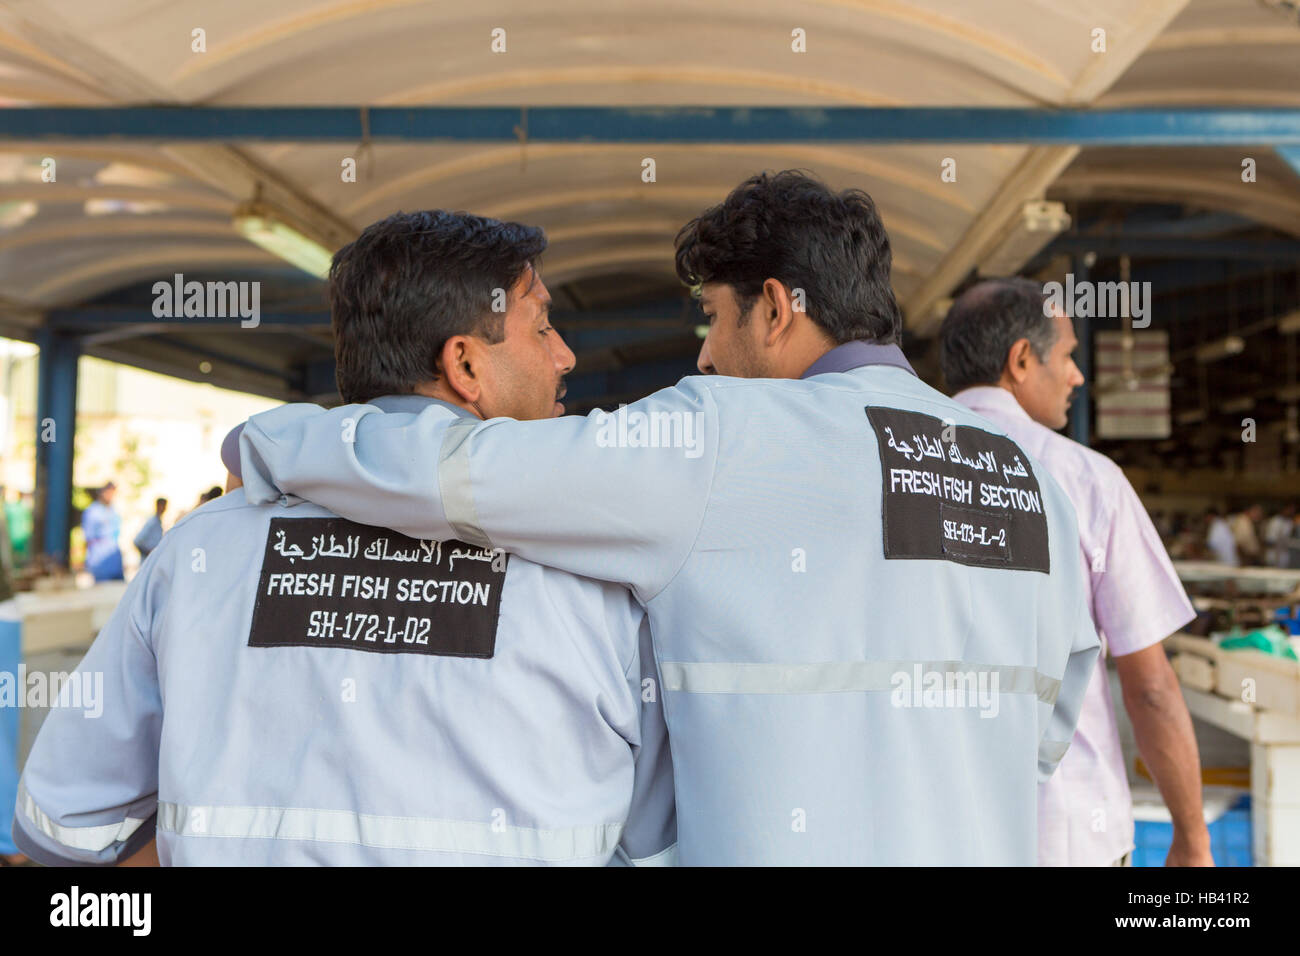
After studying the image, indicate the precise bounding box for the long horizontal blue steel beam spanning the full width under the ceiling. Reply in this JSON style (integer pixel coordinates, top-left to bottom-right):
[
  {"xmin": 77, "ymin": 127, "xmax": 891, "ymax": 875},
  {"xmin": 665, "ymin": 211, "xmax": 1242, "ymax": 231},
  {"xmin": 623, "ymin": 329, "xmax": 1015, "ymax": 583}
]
[{"xmin": 0, "ymin": 107, "xmax": 1300, "ymax": 146}]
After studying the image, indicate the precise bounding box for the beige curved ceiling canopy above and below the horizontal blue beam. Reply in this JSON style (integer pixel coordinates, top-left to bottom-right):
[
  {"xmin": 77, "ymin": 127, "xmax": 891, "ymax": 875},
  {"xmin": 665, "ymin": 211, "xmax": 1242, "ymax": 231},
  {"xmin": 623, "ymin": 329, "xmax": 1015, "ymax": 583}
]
[{"xmin": 0, "ymin": 0, "xmax": 1300, "ymax": 371}]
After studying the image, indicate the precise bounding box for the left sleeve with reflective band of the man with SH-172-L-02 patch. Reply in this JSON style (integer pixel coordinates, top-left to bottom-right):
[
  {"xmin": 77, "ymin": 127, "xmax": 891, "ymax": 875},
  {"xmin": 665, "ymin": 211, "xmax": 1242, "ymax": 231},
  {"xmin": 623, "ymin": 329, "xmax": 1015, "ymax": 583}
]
[{"xmin": 13, "ymin": 566, "xmax": 163, "ymax": 866}]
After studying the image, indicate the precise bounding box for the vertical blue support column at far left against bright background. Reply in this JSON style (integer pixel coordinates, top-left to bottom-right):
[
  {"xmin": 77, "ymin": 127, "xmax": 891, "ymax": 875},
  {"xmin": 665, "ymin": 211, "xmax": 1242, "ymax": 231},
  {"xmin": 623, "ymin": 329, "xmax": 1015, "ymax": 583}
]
[{"xmin": 34, "ymin": 329, "xmax": 81, "ymax": 566}]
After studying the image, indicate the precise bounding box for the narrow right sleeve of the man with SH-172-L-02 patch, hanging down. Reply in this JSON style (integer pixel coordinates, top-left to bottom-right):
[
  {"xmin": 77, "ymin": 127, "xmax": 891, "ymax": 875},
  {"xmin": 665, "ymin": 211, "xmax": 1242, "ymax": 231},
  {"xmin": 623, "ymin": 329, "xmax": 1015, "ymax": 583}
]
[{"xmin": 616, "ymin": 618, "xmax": 677, "ymax": 866}]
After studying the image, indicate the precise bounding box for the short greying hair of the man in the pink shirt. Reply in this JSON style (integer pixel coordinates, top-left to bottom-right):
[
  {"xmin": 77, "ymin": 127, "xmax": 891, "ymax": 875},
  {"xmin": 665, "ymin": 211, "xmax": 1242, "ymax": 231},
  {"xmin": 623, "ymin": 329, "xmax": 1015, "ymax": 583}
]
[{"xmin": 939, "ymin": 278, "xmax": 1057, "ymax": 392}]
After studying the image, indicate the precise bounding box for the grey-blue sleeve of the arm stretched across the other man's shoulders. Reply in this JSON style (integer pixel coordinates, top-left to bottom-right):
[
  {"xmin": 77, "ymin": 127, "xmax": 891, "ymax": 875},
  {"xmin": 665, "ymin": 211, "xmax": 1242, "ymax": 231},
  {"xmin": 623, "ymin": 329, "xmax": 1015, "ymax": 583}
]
[{"xmin": 241, "ymin": 378, "xmax": 719, "ymax": 601}]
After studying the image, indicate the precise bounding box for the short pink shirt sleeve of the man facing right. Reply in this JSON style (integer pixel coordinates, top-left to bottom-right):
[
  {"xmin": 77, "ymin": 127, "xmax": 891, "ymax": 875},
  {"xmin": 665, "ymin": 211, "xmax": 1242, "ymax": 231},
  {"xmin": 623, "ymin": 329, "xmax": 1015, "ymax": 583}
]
[{"xmin": 1091, "ymin": 473, "xmax": 1196, "ymax": 657}]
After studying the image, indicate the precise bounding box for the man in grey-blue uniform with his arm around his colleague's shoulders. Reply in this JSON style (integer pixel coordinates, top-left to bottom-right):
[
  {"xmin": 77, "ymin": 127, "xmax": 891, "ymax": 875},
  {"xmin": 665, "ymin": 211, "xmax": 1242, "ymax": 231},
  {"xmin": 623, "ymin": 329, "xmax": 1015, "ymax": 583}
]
[{"xmin": 242, "ymin": 173, "xmax": 1097, "ymax": 865}]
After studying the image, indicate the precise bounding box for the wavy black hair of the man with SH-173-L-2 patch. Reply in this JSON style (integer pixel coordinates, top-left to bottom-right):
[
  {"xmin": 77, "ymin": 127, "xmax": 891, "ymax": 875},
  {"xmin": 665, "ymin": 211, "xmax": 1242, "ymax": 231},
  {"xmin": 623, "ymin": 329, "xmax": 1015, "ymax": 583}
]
[{"xmin": 676, "ymin": 169, "xmax": 902, "ymax": 345}]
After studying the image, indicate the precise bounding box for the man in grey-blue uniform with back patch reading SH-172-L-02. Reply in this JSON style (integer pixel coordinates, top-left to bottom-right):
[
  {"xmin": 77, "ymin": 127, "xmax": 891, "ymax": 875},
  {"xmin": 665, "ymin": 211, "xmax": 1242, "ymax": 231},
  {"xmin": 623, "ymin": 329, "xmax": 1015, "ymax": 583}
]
[{"xmin": 14, "ymin": 212, "xmax": 673, "ymax": 865}]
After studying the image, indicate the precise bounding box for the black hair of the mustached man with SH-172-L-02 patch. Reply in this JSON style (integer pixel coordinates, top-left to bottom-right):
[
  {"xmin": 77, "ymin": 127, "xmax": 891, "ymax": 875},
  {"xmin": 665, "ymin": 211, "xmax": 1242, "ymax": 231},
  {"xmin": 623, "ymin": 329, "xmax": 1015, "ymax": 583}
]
[{"xmin": 329, "ymin": 209, "xmax": 546, "ymax": 403}]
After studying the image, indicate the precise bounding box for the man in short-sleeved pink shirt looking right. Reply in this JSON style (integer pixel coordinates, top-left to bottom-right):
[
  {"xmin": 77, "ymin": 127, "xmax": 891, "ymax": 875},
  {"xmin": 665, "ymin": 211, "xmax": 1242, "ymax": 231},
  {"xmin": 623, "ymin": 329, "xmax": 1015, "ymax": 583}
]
[{"xmin": 940, "ymin": 278, "xmax": 1214, "ymax": 866}]
